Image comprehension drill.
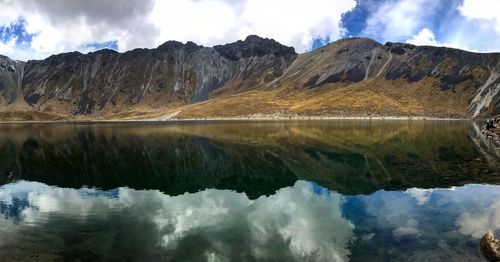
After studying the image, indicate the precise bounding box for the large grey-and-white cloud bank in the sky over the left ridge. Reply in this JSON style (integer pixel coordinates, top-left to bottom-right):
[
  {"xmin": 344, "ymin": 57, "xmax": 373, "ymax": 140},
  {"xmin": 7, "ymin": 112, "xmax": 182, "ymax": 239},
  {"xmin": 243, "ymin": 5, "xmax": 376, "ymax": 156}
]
[{"xmin": 0, "ymin": 0, "xmax": 356, "ymax": 59}]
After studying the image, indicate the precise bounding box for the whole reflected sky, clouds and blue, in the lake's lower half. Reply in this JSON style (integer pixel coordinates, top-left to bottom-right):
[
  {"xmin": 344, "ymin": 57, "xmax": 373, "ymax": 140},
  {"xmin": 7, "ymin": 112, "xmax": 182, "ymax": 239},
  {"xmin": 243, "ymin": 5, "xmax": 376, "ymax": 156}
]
[{"xmin": 0, "ymin": 181, "xmax": 500, "ymax": 261}]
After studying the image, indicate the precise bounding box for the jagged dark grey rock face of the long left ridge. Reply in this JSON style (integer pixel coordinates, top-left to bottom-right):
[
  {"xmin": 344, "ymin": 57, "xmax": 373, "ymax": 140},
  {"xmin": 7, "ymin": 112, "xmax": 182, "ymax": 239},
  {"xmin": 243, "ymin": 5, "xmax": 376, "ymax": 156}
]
[{"xmin": 13, "ymin": 36, "xmax": 296, "ymax": 114}]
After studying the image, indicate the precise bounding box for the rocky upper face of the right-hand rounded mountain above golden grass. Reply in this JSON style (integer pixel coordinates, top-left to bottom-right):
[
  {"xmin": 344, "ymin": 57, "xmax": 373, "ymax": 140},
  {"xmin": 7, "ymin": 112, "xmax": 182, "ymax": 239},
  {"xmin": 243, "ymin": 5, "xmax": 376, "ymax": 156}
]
[{"xmin": 281, "ymin": 38, "xmax": 500, "ymax": 117}]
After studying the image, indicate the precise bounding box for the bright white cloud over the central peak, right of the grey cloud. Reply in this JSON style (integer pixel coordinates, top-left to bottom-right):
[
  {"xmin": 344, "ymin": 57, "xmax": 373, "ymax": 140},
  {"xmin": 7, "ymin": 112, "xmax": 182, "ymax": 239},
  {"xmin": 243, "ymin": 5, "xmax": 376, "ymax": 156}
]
[{"xmin": 139, "ymin": 0, "xmax": 356, "ymax": 52}]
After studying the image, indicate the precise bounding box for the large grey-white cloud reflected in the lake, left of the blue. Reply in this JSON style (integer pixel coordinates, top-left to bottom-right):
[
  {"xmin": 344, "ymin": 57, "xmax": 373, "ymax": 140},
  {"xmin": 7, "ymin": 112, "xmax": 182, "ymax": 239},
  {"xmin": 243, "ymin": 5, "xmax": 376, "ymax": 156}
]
[{"xmin": 0, "ymin": 181, "xmax": 354, "ymax": 261}]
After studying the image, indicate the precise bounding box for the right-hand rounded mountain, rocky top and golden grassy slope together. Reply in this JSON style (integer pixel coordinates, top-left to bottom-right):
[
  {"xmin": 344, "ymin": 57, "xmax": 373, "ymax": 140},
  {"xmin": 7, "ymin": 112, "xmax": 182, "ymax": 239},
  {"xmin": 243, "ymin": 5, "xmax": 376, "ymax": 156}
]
[{"xmin": 176, "ymin": 38, "xmax": 500, "ymax": 118}]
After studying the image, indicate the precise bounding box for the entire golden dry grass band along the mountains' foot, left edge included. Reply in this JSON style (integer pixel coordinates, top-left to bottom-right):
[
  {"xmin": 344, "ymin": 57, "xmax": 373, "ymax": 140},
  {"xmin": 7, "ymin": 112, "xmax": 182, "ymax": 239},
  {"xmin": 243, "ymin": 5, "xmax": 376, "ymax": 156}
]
[{"xmin": 0, "ymin": 78, "xmax": 474, "ymax": 121}]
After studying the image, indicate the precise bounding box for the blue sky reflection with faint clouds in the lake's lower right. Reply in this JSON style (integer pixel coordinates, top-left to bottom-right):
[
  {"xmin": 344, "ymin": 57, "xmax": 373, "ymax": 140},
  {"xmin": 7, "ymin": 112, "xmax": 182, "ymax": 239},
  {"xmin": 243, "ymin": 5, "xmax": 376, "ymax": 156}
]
[{"xmin": 343, "ymin": 185, "xmax": 500, "ymax": 261}]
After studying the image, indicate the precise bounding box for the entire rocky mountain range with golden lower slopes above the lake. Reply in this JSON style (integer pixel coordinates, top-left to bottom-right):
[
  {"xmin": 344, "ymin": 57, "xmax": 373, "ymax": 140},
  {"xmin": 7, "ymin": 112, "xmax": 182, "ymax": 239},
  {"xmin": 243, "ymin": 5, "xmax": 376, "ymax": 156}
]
[{"xmin": 0, "ymin": 36, "xmax": 500, "ymax": 120}]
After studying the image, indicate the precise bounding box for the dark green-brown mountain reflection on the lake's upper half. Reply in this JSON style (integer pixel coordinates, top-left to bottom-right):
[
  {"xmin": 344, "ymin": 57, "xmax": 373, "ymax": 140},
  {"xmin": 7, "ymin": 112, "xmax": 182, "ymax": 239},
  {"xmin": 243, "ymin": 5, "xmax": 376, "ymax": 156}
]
[{"xmin": 0, "ymin": 121, "xmax": 500, "ymax": 195}]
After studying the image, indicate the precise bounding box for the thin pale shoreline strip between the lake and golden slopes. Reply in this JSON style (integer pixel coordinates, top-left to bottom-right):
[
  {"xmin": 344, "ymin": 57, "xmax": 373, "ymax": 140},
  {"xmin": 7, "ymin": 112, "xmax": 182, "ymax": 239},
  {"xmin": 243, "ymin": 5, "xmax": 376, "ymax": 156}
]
[{"xmin": 0, "ymin": 116, "xmax": 472, "ymax": 124}]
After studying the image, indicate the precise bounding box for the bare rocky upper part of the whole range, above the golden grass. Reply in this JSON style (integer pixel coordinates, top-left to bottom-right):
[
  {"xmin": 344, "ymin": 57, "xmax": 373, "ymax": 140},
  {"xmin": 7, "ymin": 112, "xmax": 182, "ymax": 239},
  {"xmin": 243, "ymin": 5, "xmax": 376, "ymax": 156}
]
[{"xmin": 0, "ymin": 36, "xmax": 500, "ymax": 117}]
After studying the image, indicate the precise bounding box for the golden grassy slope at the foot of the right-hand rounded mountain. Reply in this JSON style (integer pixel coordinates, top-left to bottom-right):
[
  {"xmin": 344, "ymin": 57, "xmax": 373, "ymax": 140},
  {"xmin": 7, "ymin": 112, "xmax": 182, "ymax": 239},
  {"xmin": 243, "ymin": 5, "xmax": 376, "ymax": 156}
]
[{"xmin": 177, "ymin": 79, "xmax": 472, "ymax": 118}]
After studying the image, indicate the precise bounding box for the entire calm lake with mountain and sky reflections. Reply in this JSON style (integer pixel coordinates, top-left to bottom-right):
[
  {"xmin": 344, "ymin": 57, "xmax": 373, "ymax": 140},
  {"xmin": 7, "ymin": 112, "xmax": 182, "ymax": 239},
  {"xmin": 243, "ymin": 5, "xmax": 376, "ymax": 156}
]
[{"xmin": 0, "ymin": 120, "xmax": 500, "ymax": 261}]
